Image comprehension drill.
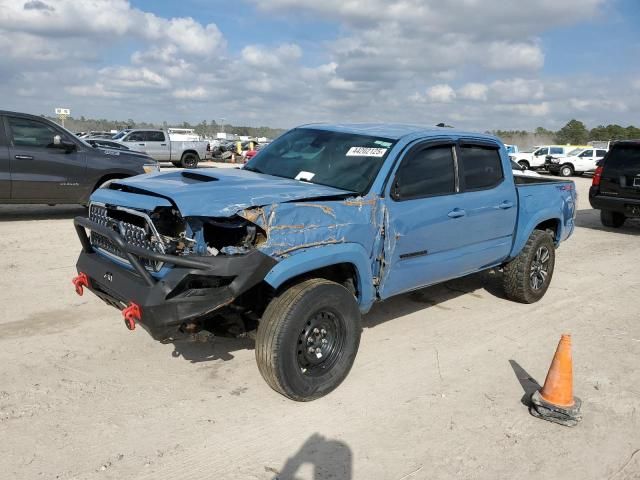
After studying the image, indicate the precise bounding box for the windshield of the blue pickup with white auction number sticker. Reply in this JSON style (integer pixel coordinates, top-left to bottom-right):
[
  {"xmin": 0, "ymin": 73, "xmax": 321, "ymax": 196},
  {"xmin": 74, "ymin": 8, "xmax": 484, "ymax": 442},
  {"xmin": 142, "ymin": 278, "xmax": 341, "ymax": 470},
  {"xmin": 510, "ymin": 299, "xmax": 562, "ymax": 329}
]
[{"xmin": 244, "ymin": 128, "xmax": 395, "ymax": 194}]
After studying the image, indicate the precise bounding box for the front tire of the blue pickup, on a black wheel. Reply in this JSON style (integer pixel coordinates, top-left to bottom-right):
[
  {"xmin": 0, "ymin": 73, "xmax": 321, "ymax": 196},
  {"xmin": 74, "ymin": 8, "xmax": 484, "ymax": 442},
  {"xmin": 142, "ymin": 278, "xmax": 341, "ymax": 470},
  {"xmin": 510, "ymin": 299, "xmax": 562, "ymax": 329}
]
[{"xmin": 256, "ymin": 278, "xmax": 362, "ymax": 402}]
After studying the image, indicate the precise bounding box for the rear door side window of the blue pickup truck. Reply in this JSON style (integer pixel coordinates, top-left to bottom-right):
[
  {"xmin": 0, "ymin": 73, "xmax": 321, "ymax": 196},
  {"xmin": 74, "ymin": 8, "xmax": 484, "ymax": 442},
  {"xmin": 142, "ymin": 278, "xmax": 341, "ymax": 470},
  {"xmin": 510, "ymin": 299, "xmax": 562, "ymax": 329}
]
[{"xmin": 458, "ymin": 145, "xmax": 504, "ymax": 190}]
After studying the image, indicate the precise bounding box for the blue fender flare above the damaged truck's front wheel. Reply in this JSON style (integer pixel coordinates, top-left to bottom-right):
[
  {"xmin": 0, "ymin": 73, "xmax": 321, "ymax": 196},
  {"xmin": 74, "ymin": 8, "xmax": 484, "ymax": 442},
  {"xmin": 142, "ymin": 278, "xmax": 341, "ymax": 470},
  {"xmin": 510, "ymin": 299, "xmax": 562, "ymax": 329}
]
[{"xmin": 264, "ymin": 243, "xmax": 376, "ymax": 313}]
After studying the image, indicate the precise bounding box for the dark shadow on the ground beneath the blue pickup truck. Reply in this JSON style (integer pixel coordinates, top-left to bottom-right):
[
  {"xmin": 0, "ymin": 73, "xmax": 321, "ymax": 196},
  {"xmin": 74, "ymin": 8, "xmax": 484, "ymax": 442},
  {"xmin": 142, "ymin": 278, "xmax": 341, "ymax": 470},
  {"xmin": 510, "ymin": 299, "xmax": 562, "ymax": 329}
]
[{"xmin": 171, "ymin": 271, "xmax": 505, "ymax": 363}]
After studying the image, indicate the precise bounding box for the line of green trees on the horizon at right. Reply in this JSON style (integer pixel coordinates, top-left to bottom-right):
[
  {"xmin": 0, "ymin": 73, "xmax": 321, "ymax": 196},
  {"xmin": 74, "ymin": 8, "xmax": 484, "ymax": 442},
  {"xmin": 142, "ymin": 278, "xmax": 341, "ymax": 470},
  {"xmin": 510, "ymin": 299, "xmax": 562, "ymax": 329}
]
[{"xmin": 488, "ymin": 119, "xmax": 640, "ymax": 145}]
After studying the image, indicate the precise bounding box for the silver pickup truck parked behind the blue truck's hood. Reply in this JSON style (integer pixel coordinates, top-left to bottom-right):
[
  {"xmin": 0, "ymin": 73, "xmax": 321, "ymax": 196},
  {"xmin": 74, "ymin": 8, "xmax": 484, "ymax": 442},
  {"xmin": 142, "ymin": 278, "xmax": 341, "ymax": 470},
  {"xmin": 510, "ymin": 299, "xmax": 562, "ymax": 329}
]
[{"xmin": 116, "ymin": 129, "xmax": 209, "ymax": 168}]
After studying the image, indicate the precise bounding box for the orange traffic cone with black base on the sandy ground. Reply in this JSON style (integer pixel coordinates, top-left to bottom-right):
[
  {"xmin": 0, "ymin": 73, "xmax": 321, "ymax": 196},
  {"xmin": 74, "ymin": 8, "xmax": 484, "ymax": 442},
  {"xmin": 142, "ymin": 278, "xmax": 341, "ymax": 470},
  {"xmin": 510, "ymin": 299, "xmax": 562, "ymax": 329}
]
[{"xmin": 529, "ymin": 335, "xmax": 582, "ymax": 427}]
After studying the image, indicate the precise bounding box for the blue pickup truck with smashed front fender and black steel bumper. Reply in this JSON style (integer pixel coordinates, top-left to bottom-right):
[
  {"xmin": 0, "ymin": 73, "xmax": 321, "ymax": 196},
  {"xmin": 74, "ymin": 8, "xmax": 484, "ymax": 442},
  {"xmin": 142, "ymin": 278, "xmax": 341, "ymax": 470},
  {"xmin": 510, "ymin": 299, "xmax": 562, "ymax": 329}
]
[{"xmin": 74, "ymin": 124, "xmax": 576, "ymax": 401}]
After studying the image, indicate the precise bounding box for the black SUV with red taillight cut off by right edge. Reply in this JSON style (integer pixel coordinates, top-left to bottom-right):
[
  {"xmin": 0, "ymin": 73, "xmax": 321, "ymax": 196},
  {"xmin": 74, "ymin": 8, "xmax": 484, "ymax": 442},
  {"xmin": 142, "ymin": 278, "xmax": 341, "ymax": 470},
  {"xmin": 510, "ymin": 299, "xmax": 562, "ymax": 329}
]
[{"xmin": 589, "ymin": 140, "xmax": 640, "ymax": 228}]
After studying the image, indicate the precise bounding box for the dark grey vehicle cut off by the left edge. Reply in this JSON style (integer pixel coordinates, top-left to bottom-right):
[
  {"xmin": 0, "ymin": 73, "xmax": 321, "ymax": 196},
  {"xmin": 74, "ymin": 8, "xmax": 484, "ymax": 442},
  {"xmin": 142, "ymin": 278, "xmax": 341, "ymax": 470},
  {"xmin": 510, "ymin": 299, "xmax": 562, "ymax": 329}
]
[{"xmin": 0, "ymin": 110, "xmax": 159, "ymax": 204}]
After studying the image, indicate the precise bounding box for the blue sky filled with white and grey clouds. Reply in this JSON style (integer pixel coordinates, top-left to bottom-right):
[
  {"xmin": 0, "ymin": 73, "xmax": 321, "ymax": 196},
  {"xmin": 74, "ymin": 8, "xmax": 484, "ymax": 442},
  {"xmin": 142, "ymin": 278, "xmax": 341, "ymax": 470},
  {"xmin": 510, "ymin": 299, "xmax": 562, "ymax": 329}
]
[{"xmin": 0, "ymin": 0, "xmax": 640, "ymax": 131}]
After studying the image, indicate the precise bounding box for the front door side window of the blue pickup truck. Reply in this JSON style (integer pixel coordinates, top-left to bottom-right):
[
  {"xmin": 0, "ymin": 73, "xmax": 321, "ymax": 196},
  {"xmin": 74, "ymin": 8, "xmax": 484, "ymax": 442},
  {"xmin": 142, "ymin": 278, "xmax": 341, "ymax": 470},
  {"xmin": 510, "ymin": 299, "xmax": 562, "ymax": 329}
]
[{"xmin": 393, "ymin": 145, "xmax": 456, "ymax": 200}]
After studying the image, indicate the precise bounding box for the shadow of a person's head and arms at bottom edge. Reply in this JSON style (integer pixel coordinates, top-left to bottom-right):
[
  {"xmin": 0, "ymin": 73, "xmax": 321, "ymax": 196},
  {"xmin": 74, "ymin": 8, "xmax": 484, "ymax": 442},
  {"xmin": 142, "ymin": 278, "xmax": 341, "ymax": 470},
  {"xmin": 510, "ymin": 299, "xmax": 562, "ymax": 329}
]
[{"xmin": 265, "ymin": 433, "xmax": 353, "ymax": 480}]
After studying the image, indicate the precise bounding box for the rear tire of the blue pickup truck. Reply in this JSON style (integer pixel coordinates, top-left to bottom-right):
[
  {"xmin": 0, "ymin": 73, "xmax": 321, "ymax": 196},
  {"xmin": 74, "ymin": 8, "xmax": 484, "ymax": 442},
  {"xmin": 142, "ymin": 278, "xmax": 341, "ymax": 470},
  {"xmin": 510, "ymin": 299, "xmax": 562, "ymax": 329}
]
[{"xmin": 502, "ymin": 230, "xmax": 556, "ymax": 303}]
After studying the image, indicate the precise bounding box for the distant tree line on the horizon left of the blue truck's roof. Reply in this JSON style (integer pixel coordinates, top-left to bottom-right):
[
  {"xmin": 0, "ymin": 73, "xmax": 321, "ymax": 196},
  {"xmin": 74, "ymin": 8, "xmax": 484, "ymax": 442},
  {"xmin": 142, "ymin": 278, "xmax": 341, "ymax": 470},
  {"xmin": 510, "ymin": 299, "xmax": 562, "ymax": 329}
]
[{"xmin": 42, "ymin": 115, "xmax": 284, "ymax": 138}]
